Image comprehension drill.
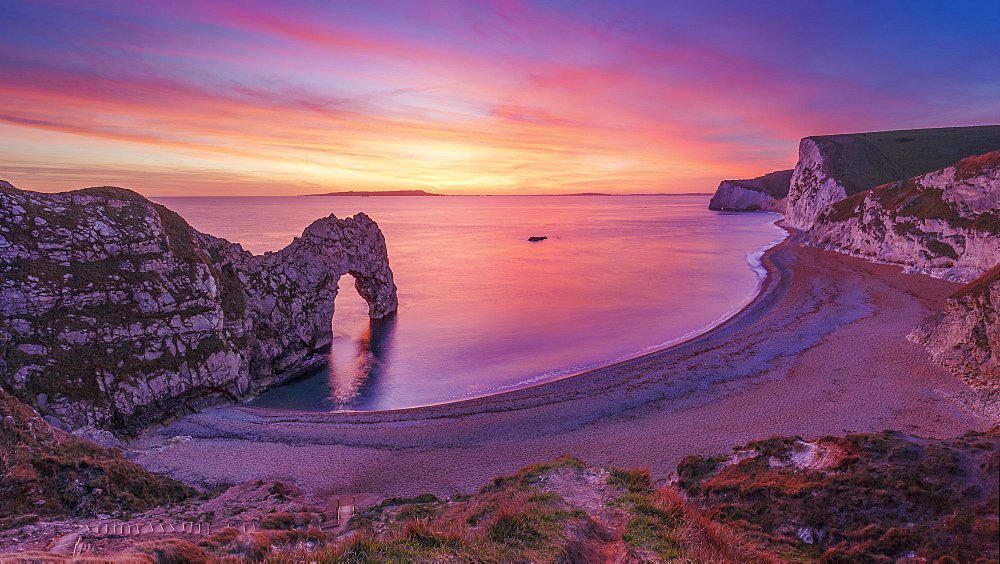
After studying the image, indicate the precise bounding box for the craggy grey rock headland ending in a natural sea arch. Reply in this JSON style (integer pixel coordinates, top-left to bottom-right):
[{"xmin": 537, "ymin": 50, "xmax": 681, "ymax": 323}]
[{"xmin": 0, "ymin": 183, "xmax": 396, "ymax": 433}]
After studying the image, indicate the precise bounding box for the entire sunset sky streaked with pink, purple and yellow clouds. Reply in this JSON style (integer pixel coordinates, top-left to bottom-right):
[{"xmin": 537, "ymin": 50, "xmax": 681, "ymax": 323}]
[{"xmin": 0, "ymin": 0, "xmax": 1000, "ymax": 196}]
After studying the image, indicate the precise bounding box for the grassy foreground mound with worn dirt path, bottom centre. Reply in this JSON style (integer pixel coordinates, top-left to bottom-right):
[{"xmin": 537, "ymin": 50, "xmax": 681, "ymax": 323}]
[{"xmin": 330, "ymin": 456, "xmax": 769, "ymax": 562}]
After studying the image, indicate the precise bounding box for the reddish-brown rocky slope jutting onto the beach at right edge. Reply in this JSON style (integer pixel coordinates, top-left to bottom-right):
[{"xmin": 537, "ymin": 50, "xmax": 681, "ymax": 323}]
[{"xmin": 909, "ymin": 265, "xmax": 1000, "ymax": 392}]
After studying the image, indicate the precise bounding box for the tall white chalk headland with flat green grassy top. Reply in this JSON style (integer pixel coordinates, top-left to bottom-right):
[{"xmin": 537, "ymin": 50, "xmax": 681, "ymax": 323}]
[{"xmin": 785, "ymin": 125, "xmax": 1000, "ymax": 229}]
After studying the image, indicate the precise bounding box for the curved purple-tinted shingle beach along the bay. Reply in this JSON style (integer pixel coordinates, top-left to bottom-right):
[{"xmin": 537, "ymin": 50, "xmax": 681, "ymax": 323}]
[{"xmin": 130, "ymin": 229, "xmax": 992, "ymax": 496}]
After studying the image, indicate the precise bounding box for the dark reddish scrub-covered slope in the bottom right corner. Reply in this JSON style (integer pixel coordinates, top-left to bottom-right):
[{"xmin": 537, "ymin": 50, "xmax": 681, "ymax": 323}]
[{"xmin": 677, "ymin": 427, "xmax": 1000, "ymax": 562}]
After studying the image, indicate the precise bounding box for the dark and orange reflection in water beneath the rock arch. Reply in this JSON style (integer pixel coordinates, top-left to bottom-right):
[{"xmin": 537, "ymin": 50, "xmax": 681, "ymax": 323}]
[{"xmin": 329, "ymin": 313, "xmax": 396, "ymax": 409}]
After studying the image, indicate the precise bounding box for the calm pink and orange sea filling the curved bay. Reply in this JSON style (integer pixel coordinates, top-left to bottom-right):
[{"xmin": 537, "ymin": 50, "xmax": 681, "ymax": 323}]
[{"xmin": 157, "ymin": 196, "xmax": 783, "ymax": 411}]
